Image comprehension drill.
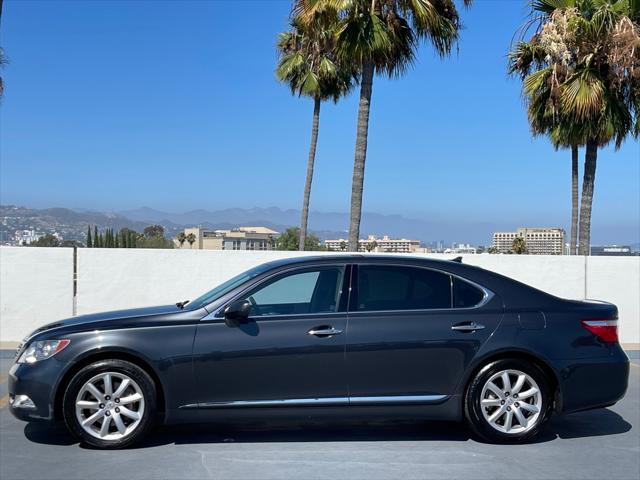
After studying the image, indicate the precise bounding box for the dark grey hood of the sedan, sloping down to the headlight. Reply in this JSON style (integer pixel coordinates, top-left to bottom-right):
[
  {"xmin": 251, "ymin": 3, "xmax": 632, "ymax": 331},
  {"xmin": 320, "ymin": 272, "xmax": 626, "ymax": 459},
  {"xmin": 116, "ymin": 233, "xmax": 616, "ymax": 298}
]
[{"xmin": 29, "ymin": 305, "xmax": 184, "ymax": 338}]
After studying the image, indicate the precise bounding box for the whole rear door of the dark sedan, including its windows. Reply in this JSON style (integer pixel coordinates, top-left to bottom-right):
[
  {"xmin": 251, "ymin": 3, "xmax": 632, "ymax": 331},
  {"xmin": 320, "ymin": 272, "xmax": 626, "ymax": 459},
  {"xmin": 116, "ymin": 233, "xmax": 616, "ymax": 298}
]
[{"xmin": 346, "ymin": 264, "xmax": 502, "ymax": 404}]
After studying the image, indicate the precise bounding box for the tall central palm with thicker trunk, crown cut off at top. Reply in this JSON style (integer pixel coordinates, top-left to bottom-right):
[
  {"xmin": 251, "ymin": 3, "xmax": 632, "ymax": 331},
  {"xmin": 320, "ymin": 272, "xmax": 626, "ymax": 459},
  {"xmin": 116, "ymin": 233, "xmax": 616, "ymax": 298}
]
[{"xmin": 294, "ymin": 0, "xmax": 471, "ymax": 252}]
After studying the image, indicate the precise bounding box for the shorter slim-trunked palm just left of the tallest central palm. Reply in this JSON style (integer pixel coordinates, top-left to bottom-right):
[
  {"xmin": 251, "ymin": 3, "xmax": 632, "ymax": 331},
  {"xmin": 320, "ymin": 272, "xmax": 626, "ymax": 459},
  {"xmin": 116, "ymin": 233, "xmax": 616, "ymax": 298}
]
[{"xmin": 276, "ymin": 13, "xmax": 355, "ymax": 250}]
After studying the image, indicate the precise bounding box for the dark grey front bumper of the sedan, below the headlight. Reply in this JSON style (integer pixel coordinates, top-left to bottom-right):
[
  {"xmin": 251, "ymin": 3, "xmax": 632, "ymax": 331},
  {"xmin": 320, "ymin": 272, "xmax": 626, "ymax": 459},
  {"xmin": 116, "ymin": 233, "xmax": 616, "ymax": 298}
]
[{"xmin": 8, "ymin": 358, "xmax": 63, "ymax": 421}]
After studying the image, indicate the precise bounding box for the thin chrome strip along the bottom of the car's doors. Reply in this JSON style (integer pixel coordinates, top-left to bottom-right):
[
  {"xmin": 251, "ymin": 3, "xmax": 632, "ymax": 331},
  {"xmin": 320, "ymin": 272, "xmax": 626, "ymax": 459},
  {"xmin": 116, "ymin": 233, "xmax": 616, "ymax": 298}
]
[{"xmin": 180, "ymin": 395, "xmax": 448, "ymax": 409}]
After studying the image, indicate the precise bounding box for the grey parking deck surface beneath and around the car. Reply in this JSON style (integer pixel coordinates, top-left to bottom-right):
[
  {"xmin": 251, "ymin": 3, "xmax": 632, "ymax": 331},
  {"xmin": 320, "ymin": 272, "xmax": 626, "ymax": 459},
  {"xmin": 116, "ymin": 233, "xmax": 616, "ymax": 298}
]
[{"xmin": 0, "ymin": 354, "xmax": 640, "ymax": 480}]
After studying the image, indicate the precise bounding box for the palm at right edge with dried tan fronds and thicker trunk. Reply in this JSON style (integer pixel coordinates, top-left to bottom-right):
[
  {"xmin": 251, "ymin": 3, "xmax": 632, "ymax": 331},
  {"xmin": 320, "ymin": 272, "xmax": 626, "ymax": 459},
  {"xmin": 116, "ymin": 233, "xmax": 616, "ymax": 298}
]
[{"xmin": 524, "ymin": 0, "xmax": 640, "ymax": 255}]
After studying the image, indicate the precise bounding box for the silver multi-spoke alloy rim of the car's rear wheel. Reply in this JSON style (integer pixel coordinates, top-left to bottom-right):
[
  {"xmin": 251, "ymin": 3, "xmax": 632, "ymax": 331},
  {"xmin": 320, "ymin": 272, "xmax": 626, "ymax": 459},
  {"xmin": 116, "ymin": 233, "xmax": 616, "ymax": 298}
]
[{"xmin": 480, "ymin": 370, "xmax": 542, "ymax": 435}]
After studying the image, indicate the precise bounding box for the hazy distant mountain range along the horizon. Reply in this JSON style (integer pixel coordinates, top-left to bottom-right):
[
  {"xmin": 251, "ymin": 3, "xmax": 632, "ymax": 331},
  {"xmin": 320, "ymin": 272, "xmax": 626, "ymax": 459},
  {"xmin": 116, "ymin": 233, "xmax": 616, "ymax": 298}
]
[{"xmin": 0, "ymin": 205, "xmax": 638, "ymax": 248}]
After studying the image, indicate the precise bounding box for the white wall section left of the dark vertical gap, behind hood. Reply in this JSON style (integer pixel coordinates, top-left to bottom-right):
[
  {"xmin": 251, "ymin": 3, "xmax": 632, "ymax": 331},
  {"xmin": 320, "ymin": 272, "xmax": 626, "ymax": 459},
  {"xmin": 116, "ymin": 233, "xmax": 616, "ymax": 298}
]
[{"xmin": 0, "ymin": 247, "xmax": 73, "ymax": 342}]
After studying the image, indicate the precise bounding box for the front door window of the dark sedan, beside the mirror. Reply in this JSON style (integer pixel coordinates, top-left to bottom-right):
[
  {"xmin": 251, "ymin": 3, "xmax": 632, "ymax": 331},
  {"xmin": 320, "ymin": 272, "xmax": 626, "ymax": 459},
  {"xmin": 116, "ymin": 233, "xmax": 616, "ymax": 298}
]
[{"xmin": 240, "ymin": 267, "xmax": 344, "ymax": 316}]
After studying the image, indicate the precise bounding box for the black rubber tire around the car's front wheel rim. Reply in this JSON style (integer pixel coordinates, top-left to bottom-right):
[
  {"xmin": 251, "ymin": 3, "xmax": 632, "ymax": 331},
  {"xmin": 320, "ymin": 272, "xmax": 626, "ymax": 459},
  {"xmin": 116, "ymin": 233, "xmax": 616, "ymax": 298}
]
[{"xmin": 62, "ymin": 359, "xmax": 157, "ymax": 449}]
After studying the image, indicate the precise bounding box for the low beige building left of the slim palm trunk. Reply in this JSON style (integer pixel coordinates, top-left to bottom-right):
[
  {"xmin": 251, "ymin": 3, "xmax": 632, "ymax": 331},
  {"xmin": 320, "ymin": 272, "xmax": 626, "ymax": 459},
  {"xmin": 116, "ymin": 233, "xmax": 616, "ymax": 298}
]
[{"xmin": 174, "ymin": 227, "xmax": 280, "ymax": 250}]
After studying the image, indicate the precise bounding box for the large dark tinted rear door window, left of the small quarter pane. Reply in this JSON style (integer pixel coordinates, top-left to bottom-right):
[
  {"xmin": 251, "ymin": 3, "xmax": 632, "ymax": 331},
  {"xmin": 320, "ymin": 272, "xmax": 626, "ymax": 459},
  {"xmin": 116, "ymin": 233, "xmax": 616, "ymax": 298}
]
[{"xmin": 356, "ymin": 265, "xmax": 452, "ymax": 311}]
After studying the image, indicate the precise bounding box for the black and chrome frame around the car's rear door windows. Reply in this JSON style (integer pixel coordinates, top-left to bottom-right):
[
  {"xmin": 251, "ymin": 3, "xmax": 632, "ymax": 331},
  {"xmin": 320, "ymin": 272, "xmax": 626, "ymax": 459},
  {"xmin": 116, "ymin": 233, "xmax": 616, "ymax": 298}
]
[{"xmin": 348, "ymin": 263, "xmax": 495, "ymax": 314}]
